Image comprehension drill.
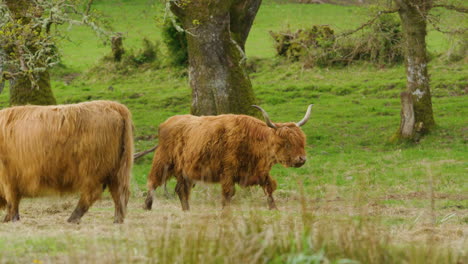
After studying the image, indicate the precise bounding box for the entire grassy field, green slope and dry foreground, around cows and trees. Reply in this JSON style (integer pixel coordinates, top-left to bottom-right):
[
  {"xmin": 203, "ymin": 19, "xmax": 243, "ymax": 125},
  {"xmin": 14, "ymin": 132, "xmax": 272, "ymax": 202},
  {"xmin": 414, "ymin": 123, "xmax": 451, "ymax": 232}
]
[{"xmin": 0, "ymin": 0, "xmax": 468, "ymax": 263}]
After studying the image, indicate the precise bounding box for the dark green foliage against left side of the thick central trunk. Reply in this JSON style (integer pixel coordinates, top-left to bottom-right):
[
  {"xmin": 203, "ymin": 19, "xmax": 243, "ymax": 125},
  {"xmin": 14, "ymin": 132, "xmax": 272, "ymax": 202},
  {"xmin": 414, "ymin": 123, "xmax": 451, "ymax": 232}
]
[{"xmin": 162, "ymin": 18, "xmax": 188, "ymax": 67}]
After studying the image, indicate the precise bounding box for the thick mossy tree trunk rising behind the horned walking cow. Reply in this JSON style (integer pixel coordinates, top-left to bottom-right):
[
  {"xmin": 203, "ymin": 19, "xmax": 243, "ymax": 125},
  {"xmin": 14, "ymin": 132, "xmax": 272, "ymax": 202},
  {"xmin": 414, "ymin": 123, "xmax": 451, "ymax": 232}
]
[{"xmin": 171, "ymin": 0, "xmax": 261, "ymax": 115}]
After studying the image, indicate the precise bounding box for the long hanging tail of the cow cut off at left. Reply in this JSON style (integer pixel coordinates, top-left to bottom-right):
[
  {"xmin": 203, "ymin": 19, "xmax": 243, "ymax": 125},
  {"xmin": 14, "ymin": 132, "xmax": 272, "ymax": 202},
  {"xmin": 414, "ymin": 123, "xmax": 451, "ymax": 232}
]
[{"xmin": 117, "ymin": 106, "xmax": 133, "ymax": 216}]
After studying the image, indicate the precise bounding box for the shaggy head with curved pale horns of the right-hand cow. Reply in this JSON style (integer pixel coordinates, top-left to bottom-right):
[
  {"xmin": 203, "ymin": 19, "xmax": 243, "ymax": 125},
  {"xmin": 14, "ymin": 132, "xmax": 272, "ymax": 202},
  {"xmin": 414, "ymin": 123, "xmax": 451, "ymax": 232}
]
[{"xmin": 253, "ymin": 105, "xmax": 312, "ymax": 167}]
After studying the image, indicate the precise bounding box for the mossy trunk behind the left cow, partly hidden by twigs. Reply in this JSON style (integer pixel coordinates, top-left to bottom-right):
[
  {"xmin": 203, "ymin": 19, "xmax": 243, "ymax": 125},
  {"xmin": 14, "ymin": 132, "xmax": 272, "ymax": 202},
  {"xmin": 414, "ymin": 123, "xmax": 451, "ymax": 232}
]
[{"xmin": 5, "ymin": 0, "xmax": 56, "ymax": 105}]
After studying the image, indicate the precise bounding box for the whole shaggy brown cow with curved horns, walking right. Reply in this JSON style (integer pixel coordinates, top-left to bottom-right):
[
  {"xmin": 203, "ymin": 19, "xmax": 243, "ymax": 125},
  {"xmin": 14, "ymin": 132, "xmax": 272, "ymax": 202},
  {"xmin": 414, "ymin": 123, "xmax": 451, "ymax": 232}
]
[{"xmin": 145, "ymin": 105, "xmax": 312, "ymax": 210}]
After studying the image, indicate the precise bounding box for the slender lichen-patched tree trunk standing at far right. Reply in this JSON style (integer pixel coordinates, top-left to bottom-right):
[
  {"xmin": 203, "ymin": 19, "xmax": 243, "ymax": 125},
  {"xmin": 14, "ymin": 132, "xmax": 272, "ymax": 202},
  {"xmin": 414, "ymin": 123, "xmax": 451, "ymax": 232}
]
[{"xmin": 394, "ymin": 0, "xmax": 435, "ymax": 140}]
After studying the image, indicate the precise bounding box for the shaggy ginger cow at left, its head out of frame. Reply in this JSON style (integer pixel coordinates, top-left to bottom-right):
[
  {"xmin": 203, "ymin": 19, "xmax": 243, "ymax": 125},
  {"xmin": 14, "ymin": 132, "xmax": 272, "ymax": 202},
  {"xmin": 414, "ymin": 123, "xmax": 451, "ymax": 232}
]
[{"xmin": 0, "ymin": 101, "xmax": 133, "ymax": 223}]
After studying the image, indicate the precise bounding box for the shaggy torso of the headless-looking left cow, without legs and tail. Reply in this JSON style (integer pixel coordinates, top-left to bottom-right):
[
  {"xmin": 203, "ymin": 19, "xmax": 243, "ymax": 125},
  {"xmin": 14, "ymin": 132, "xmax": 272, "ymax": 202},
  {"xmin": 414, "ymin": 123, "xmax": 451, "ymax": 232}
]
[{"xmin": 0, "ymin": 101, "xmax": 129, "ymax": 196}]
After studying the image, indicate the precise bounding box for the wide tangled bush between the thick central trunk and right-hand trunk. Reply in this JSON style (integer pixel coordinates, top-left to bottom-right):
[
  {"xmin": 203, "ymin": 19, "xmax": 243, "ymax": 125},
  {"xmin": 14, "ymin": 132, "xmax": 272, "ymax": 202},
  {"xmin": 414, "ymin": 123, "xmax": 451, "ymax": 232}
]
[{"xmin": 270, "ymin": 15, "xmax": 404, "ymax": 67}]
